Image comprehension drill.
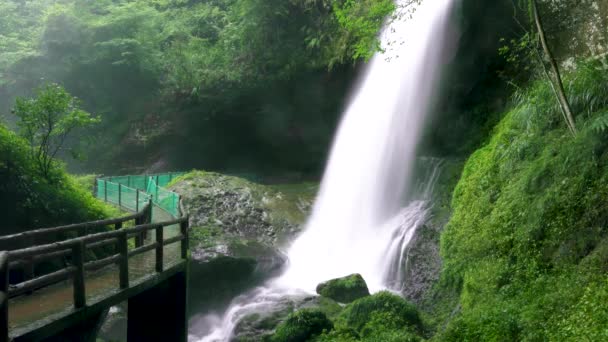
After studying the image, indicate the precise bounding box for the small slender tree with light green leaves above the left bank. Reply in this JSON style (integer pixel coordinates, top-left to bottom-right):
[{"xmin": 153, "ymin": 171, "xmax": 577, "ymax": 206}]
[{"xmin": 13, "ymin": 84, "xmax": 101, "ymax": 179}]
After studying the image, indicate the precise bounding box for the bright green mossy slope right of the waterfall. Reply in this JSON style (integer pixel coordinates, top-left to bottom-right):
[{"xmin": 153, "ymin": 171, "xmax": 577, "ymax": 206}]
[{"xmin": 437, "ymin": 66, "xmax": 608, "ymax": 341}]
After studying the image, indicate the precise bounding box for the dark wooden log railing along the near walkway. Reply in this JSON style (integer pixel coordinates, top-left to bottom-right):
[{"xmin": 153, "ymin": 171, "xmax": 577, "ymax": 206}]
[{"xmin": 0, "ymin": 214, "xmax": 189, "ymax": 340}]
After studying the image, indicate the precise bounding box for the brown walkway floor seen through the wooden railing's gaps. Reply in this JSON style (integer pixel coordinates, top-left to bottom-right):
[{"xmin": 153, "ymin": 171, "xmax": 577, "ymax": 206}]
[{"xmin": 9, "ymin": 207, "xmax": 182, "ymax": 337}]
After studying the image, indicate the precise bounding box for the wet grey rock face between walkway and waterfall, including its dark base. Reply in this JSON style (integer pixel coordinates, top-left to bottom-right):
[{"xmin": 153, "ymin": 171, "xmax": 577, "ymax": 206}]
[{"xmin": 170, "ymin": 171, "xmax": 316, "ymax": 316}]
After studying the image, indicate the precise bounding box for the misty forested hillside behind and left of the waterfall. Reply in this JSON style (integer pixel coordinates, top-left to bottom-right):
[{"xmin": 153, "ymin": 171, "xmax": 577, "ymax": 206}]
[{"xmin": 0, "ymin": 0, "xmax": 400, "ymax": 174}]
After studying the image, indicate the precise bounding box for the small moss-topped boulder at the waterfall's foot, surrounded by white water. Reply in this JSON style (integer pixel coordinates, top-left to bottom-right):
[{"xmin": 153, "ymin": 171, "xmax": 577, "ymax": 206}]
[{"xmin": 317, "ymin": 274, "xmax": 369, "ymax": 303}]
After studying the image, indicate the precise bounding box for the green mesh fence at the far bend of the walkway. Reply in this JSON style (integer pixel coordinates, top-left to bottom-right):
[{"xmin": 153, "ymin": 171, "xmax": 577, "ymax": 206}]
[{"xmin": 96, "ymin": 172, "xmax": 184, "ymax": 217}]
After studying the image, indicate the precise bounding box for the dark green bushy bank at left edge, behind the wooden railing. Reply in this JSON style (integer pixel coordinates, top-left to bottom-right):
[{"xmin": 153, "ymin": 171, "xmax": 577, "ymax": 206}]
[{"xmin": 0, "ymin": 125, "xmax": 117, "ymax": 234}]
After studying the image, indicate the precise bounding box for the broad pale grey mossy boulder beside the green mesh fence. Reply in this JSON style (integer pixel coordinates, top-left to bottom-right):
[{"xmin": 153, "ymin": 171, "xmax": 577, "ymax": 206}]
[{"xmin": 170, "ymin": 171, "xmax": 318, "ymax": 245}]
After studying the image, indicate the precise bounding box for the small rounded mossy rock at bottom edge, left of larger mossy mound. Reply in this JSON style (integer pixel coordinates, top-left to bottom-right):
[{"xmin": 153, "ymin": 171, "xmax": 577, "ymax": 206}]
[{"xmin": 270, "ymin": 309, "xmax": 333, "ymax": 342}]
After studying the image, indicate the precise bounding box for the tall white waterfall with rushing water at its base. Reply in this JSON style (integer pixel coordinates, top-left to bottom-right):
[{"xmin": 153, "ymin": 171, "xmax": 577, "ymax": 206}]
[{"xmin": 191, "ymin": 0, "xmax": 452, "ymax": 341}]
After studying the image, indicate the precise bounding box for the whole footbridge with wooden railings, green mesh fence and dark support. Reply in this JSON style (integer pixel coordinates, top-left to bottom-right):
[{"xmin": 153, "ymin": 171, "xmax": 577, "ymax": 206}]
[{"xmin": 0, "ymin": 173, "xmax": 188, "ymax": 342}]
